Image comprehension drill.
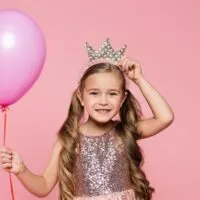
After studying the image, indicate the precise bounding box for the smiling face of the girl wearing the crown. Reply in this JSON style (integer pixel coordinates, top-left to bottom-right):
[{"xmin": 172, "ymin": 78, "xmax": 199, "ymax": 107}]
[{"xmin": 80, "ymin": 72, "xmax": 126, "ymax": 123}]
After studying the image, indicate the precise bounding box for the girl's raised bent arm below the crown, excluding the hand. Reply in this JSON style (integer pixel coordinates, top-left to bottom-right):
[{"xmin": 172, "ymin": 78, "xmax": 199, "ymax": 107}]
[{"xmin": 135, "ymin": 76, "xmax": 174, "ymax": 138}]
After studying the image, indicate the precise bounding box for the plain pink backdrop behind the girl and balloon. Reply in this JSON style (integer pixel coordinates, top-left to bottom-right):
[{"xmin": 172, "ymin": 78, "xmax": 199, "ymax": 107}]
[{"xmin": 0, "ymin": 0, "xmax": 200, "ymax": 200}]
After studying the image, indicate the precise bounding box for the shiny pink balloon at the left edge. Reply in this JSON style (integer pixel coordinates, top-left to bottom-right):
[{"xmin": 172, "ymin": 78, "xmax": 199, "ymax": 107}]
[{"xmin": 0, "ymin": 10, "xmax": 46, "ymax": 107}]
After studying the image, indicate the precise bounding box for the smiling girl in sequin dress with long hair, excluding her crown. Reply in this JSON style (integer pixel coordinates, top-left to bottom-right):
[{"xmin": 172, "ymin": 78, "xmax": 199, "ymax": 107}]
[{"xmin": 0, "ymin": 39, "xmax": 173, "ymax": 200}]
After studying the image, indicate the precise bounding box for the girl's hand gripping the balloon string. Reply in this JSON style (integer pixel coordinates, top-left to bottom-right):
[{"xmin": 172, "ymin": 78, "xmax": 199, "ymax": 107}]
[{"xmin": 0, "ymin": 146, "xmax": 25, "ymax": 175}]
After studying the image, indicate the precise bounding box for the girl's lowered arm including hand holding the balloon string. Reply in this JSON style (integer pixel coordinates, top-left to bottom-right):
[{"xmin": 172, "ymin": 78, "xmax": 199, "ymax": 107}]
[{"xmin": 1, "ymin": 140, "xmax": 61, "ymax": 197}]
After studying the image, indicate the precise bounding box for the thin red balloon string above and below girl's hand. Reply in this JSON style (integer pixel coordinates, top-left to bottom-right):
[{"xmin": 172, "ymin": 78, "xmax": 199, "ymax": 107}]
[{"xmin": 0, "ymin": 107, "xmax": 15, "ymax": 200}]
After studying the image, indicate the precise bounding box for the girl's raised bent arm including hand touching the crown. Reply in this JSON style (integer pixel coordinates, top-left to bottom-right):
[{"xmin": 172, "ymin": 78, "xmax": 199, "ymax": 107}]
[{"xmin": 120, "ymin": 56, "xmax": 174, "ymax": 138}]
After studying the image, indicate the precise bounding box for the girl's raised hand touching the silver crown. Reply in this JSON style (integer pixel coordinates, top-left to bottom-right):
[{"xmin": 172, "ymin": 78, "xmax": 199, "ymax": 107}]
[{"xmin": 120, "ymin": 56, "xmax": 143, "ymax": 83}]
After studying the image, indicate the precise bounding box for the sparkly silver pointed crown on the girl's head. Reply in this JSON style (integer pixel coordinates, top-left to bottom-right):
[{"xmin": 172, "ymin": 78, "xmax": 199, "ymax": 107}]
[{"xmin": 86, "ymin": 38, "xmax": 127, "ymax": 66}]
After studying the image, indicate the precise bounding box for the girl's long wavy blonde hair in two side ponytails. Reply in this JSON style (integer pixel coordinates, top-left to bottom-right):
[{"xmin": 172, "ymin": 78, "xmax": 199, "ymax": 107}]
[{"xmin": 58, "ymin": 63, "xmax": 155, "ymax": 200}]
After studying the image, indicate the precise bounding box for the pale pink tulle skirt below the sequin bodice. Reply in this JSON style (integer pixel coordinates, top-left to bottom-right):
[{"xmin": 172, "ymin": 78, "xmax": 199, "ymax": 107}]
[{"xmin": 73, "ymin": 189, "xmax": 135, "ymax": 200}]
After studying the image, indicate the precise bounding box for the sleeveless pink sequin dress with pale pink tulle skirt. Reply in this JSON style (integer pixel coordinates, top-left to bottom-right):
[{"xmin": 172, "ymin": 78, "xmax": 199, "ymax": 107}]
[{"xmin": 73, "ymin": 122, "xmax": 135, "ymax": 200}]
